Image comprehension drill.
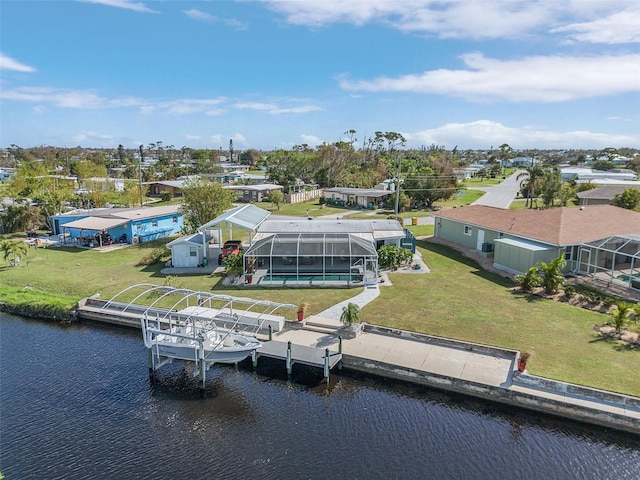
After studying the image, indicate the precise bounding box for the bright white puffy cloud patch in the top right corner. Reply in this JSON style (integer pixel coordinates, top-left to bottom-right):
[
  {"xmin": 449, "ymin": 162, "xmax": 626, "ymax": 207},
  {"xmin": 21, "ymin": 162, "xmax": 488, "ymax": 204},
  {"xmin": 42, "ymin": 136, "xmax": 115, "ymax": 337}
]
[{"xmin": 551, "ymin": 5, "xmax": 640, "ymax": 44}]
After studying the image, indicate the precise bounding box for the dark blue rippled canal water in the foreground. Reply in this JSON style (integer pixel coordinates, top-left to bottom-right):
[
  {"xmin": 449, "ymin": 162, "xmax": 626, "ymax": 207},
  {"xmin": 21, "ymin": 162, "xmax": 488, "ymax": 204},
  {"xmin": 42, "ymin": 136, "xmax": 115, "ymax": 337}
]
[{"xmin": 0, "ymin": 314, "xmax": 640, "ymax": 480}]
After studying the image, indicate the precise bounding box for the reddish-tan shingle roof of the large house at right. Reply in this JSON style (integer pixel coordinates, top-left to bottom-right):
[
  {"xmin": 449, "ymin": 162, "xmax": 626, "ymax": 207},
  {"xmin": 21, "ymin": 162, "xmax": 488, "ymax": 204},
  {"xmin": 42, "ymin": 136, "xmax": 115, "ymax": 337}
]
[{"xmin": 434, "ymin": 205, "xmax": 640, "ymax": 245}]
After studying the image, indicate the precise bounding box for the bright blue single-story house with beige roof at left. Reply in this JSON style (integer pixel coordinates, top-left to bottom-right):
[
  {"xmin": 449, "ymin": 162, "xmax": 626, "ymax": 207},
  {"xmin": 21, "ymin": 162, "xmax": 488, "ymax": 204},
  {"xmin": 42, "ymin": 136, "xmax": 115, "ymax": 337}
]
[{"xmin": 51, "ymin": 205, "xmax": 184, "ymax": 247}]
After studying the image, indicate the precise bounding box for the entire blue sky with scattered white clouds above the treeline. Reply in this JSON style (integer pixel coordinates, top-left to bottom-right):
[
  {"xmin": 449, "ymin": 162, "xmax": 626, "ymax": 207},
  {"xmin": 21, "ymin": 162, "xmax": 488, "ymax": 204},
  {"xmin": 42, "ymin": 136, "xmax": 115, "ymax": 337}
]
[{"xmin": 0, "ymin": 0, "xmax": 640, "ymax": 150}]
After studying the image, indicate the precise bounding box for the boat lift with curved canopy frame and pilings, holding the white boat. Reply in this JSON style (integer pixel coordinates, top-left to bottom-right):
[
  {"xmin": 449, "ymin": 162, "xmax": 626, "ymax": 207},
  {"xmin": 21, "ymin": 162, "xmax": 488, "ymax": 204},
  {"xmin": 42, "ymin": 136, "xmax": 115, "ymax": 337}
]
[{"xmin": 103, "ymin": 284, "xmax": 296, "ymax": 389}]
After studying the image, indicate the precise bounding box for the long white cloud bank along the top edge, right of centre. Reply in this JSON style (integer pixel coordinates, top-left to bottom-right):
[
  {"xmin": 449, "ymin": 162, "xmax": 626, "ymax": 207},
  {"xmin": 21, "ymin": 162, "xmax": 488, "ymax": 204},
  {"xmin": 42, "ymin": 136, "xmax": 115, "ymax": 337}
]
[{"xmin": 262, "ymin": 0, "xmax": 640, "ymax": 43}]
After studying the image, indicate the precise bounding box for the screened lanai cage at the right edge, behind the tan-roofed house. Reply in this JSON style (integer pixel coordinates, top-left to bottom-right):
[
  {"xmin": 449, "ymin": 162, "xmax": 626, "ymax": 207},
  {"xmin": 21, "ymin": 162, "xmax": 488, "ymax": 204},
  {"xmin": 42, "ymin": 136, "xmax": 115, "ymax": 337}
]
[{"xmin": 577, "ymin": 235, "xmax": 640, "ymax": 290}]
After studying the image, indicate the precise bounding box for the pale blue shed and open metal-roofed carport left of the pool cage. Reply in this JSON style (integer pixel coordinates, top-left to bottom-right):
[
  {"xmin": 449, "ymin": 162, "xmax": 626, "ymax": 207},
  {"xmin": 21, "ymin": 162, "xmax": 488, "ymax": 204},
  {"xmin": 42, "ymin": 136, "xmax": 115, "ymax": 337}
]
[{"xmin": 166, "ymin": 204, "xmax": 270, "ymax": 268}]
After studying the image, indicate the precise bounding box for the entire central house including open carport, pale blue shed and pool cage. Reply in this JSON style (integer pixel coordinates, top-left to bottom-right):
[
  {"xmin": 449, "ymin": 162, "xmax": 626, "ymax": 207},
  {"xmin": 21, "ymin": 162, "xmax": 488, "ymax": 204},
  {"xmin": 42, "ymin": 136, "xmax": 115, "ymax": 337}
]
[{"xmin": 167, "ymin": 205, "xmax": 407, "ymax": 285}]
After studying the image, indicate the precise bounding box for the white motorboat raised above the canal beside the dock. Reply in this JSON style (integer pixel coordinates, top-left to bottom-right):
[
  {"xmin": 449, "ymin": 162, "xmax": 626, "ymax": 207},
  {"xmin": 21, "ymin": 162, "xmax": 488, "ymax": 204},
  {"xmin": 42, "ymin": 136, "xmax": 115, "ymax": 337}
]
[{"xmin": 142, "ymin": 321, "xmax": 262, "ymax": 367}]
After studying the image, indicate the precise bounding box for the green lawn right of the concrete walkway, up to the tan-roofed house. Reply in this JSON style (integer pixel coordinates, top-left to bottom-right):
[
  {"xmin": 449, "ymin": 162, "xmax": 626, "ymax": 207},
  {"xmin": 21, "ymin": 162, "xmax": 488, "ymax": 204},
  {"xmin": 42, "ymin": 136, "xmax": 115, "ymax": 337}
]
[{"xmin": 361, "ymin": 242, "xmax": 640, "ymax": 396}]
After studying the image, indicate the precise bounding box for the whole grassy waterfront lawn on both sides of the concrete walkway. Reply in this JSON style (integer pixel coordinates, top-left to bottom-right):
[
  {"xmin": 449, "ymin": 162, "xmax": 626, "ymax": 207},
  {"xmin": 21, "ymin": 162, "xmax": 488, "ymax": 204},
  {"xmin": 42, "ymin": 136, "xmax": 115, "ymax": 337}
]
[{"xmin": 0, "ymin": 233, "xmax": 640, "ymax": 396}]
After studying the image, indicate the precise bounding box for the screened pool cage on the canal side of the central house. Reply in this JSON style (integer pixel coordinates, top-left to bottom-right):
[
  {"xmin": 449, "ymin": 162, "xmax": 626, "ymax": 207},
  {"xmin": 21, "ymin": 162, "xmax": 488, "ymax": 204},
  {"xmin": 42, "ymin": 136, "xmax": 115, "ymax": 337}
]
[{"xmin": 244, "ymin": 233, "xmax": 378, "ymax": 285}]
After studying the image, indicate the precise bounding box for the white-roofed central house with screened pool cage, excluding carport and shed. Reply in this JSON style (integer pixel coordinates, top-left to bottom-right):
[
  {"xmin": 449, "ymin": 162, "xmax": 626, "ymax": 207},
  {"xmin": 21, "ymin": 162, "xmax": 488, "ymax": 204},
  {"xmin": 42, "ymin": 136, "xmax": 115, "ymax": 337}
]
[{"xmin": 244, "ymin": 219, "xmax": 405, "ymax": 286}]
